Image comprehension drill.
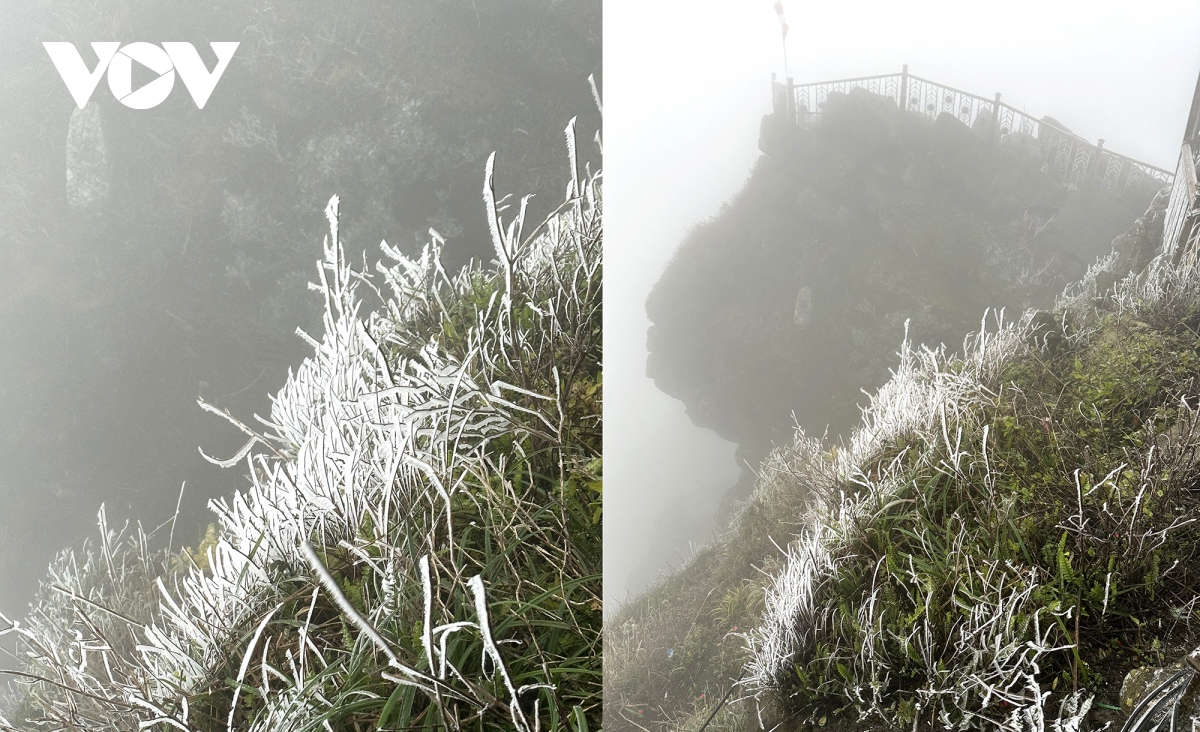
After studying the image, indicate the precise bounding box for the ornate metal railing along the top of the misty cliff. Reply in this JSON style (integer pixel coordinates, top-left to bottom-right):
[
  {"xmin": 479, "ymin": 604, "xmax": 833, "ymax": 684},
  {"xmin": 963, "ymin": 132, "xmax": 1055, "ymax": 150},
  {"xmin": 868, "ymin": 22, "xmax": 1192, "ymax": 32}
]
[{"xmin": 773, "ymin": 65, "xmax": 1175, "ymax": 191}]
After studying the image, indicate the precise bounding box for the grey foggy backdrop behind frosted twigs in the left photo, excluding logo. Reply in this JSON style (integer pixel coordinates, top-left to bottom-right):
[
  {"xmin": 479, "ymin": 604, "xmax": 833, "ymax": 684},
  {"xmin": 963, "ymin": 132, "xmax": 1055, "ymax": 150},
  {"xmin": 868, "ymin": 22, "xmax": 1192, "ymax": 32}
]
[{"xmin": 0, "ymin": 0, "xmax": 600, "ymax": 618}]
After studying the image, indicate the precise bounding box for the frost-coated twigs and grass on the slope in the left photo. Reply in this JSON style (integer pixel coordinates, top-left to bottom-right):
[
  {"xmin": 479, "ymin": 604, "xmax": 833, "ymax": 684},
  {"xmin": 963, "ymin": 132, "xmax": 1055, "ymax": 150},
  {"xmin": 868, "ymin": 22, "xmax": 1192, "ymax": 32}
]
[{"xmin": 0, "ymin": 121, "xmax": 602, "ymax": 732}]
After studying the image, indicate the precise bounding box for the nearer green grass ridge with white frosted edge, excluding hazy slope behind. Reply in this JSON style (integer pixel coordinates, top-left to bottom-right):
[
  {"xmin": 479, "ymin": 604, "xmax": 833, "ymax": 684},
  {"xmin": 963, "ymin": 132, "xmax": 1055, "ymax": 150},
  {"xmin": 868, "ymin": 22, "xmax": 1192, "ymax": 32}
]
[{"xmin": 749, "ymin": 250, "xmax": 1200, "ymax": 730}]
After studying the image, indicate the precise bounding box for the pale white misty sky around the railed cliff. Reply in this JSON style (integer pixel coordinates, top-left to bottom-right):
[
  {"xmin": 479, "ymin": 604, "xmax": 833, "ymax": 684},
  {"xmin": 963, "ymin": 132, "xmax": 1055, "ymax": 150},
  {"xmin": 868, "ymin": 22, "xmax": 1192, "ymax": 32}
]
[{"xmin": 604, "ymin": 0, "xmax": 1200, "ymax": 601}]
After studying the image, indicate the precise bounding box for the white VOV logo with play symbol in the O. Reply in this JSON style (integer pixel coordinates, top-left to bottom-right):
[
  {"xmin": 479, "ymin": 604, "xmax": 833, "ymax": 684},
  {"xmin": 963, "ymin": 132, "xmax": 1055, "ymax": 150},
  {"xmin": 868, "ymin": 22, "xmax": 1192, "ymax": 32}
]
[{"xmin": 42, "ymin": 41, "xmax": 239, "ymax": 109}]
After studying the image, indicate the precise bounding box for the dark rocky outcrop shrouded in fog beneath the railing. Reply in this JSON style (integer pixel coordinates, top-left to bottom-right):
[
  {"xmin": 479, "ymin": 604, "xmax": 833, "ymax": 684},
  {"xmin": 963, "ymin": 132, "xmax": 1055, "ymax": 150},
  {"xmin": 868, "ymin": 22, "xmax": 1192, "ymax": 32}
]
[{"xmin": 647, "ymin": 90, "xmax": 1158, "ymax": 506}]
